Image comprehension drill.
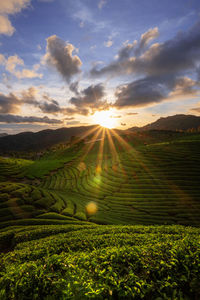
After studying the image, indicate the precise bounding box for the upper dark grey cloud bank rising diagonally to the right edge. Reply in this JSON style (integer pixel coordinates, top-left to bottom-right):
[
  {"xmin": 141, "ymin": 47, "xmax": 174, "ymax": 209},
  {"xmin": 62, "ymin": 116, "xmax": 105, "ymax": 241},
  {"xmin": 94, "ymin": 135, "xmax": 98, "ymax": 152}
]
[{"xmin": 91, "ymin": 22, "xmax": 200, "ymax": 77}]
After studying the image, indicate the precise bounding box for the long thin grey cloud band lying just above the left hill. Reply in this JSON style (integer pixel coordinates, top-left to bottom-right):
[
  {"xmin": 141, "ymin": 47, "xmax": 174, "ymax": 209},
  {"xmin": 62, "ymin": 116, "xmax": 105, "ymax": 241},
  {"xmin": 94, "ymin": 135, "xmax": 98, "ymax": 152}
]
[{"xmin": 0, "ymin": 114, "xmax": 63, "ymax": 124}]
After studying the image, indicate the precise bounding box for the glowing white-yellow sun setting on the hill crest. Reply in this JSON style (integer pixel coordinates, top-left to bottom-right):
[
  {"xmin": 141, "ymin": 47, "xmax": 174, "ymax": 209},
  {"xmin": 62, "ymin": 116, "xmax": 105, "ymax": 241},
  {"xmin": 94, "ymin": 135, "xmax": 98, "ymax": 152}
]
[{"xmin": 93, "ymin": 110, "xmax": 116, "ymax": 129}]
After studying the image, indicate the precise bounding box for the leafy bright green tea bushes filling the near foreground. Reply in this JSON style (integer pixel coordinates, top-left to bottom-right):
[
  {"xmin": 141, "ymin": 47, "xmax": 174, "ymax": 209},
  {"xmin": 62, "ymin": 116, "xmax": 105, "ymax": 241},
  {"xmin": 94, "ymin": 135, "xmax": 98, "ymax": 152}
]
[{"xmin": 0, "ymin": 225, "xmax": 200, "ymax": 300}]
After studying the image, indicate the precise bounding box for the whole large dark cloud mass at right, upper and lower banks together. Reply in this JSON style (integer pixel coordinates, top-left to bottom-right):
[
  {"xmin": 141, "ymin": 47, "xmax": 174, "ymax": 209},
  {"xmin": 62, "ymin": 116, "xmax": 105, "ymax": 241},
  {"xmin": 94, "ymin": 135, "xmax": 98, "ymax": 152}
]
[{"xmin": 91, "ymin": 22, "xmax": 200, "ymax": 108}]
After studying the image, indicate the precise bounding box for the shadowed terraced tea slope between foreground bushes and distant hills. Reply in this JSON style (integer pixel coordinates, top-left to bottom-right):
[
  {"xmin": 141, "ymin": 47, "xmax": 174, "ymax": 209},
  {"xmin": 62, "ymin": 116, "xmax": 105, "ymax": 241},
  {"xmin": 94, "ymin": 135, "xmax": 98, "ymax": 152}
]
[{"xmin": 0, "ymin": 132, "xmax": 200, "ymax": 227}]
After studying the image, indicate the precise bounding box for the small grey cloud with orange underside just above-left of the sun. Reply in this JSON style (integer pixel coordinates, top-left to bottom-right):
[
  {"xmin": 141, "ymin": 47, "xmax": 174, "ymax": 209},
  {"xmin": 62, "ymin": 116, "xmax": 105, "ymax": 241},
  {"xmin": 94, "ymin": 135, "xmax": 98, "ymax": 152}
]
[{"xmin": 70, "ymin": 84, "xmax": 108, "ymax": 111}]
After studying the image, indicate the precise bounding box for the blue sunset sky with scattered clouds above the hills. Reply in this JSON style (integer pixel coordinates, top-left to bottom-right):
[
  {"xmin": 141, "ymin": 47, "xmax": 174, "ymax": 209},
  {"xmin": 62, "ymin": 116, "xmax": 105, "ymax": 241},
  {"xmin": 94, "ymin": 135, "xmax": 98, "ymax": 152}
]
[{"xmin": 0, "ymin": 0, "xmax": 200, "ymax": 134}]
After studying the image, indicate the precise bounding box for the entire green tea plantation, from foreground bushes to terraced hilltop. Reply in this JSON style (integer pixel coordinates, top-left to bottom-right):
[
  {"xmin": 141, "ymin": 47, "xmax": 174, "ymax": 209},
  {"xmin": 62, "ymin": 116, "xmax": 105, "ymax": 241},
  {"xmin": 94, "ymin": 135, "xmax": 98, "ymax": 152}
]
[{"xmin": 0, "ymin": 130, "xmax": 200, "ymax": 300}]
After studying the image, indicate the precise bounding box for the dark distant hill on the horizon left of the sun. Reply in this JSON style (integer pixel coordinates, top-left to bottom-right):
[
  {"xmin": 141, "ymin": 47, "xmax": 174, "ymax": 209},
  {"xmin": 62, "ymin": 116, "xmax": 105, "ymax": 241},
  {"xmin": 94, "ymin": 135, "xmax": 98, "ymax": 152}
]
[{"xmin": 0, "ymin": 125, "xmax": 97, "ymax": 153}]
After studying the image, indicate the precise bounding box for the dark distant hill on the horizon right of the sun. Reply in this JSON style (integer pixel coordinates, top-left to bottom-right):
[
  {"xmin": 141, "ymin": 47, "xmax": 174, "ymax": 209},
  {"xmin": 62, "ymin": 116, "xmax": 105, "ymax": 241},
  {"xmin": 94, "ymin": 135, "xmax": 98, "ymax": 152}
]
[{"xmin": 129, "ymin": 114, "xmax": 200, "ymax": 131}]
